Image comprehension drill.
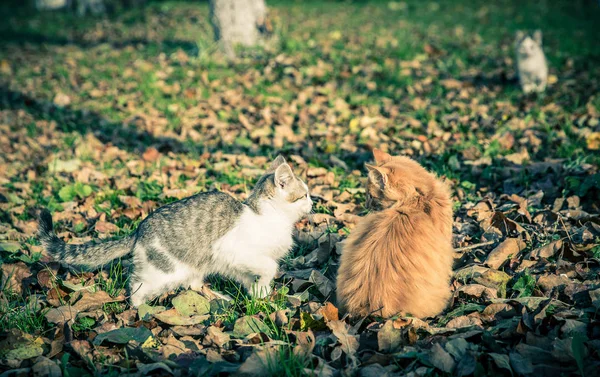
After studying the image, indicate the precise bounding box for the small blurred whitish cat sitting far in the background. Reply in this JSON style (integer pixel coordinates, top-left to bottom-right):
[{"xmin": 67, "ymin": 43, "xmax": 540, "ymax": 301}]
[{"xmin": 515, "ymin": 30, "xmax": 548, "ymax": 93}]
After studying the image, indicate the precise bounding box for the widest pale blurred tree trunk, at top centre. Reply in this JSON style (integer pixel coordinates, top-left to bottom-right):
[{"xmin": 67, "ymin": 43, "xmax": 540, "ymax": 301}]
[{"xmin": 210, "ymin": 0, "xmax": 267, "ymax": 58}]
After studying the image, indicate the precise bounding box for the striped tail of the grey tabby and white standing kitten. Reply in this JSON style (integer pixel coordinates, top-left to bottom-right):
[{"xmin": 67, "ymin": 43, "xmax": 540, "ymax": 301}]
[{"xmin": 38, "ymin": 209, "xmax": 134, "ymax": 268}]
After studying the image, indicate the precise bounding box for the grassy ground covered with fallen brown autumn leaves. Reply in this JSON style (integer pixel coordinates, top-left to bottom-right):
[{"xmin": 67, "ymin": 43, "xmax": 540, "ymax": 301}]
[{"xmin": 0, "ymin": 1, "xmax": 600, "ymax": 376}]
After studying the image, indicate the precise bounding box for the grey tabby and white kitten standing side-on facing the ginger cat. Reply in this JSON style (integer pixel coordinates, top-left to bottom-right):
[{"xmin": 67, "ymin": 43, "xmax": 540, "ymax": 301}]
[{"xmin": 38, "ymin": 156, "xmax": 312, "ymax": 307}]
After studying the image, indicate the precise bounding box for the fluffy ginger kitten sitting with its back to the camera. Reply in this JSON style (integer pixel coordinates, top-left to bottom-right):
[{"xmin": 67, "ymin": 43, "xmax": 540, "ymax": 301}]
[{"xmin": 337, "ymin": 149, "xmax": 453, "ymax": 318}]
